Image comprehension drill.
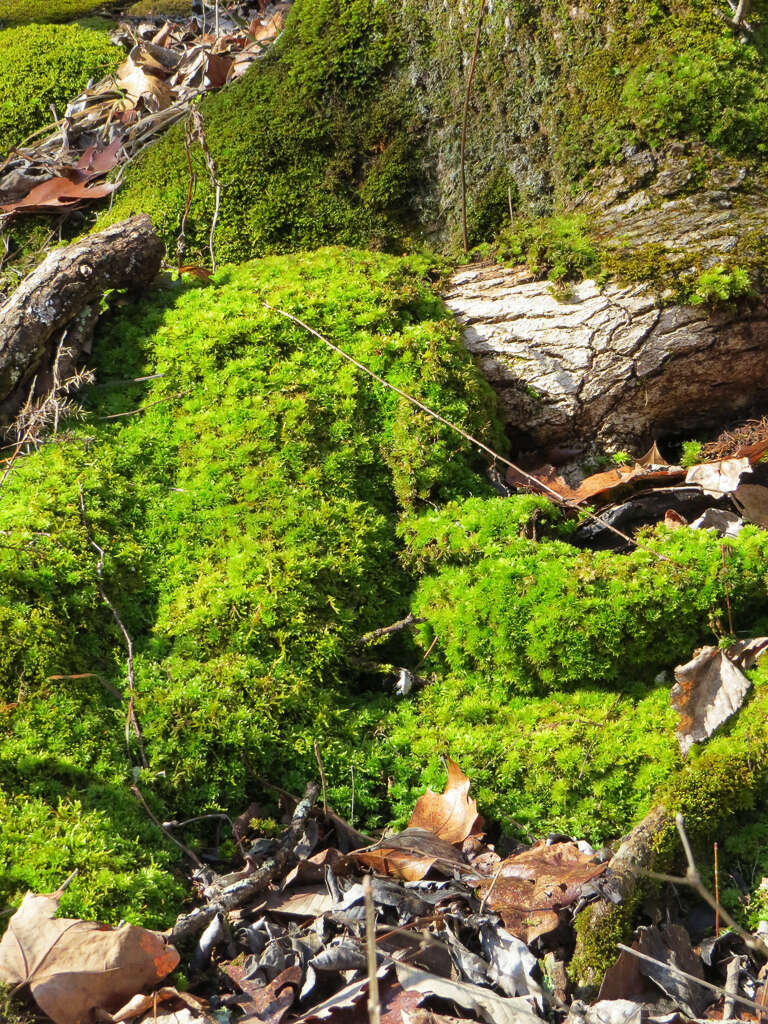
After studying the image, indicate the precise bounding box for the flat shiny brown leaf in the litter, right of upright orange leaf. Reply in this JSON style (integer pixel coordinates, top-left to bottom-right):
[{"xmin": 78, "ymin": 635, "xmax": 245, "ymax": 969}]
[{"xmin": 477, "ymin": 843, "xmax": 606, "ymax": 943}]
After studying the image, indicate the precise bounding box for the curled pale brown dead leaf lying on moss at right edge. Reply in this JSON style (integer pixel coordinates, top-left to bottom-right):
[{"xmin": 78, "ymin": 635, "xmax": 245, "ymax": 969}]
[{"xmin": 670, "ymin": 637, "xmax": 768, "ymax": 758}]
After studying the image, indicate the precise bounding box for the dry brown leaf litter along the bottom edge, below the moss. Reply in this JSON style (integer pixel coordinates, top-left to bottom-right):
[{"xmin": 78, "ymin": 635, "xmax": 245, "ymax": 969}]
[{"xmin": 0, "ymin": 761, "xmax": 768, "ymax": 1024}]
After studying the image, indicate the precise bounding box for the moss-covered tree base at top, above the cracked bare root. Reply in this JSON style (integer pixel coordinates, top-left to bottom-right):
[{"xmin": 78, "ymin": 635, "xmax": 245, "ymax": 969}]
[{"xmin": 102, "ymin": 0, "xmax": 768, "ymax": 259}]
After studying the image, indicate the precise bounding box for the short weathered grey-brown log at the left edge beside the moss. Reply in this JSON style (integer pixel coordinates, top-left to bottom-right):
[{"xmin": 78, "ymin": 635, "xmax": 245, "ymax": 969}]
[{"xmin": 0, "ymin": 214, "xmax": 165, "ymax": 424}]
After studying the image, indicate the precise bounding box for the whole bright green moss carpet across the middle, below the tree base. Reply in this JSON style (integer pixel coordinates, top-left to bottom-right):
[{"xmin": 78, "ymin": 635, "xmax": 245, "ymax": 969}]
[{"xmin": 0, "ymin": 248, "xmax": 768, "ymax": 924}]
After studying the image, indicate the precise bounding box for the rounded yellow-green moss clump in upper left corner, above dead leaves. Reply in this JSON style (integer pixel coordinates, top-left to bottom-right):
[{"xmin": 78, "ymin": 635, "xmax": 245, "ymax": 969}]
[{"xmin": 0, "ymin": 25, "xmax": 123, "ymax": 155}]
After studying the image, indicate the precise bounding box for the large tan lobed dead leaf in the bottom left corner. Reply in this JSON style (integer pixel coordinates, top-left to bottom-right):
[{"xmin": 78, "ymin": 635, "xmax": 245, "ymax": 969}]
[{"xmin": 0, "ymin": 893, "xmax": 179, "ymax": 1024}]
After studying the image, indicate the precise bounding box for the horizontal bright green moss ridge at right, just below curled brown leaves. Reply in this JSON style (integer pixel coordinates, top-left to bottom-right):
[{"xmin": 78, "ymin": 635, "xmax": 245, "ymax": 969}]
[{"xmin": 412, "ymin": 502, "xmax": 768, "ymax": 693}]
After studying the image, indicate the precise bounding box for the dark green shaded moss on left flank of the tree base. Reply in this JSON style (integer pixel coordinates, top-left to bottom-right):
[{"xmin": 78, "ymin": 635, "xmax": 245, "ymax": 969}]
[{"xmin": 102, "ymin": 0, "xmax": 418, "ymax": 260}]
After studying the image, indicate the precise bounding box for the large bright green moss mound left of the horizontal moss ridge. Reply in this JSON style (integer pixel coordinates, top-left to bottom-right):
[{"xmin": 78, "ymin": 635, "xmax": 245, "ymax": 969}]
[{"xmin": 0, "ymin": 250, "xmax": 501, "ymax": 923}]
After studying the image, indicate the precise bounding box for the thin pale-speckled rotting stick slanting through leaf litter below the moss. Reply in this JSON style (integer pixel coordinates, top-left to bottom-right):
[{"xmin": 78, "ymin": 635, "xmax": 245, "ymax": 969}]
[{"xmin": 168, "ymin": 782, "xmax": 319, "ymax": 944}]
